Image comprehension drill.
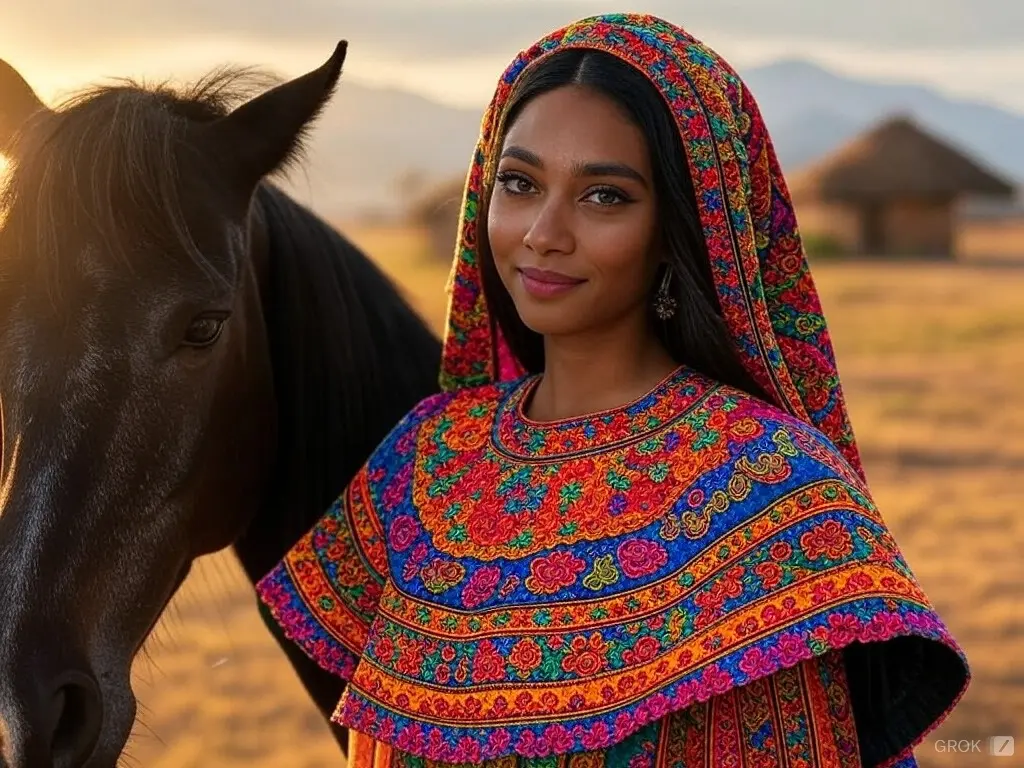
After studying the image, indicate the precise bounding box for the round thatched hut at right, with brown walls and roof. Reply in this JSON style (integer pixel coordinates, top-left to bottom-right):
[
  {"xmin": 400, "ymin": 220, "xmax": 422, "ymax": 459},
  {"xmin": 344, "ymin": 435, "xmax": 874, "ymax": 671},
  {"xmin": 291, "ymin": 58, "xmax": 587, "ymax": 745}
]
[{"xmin": 788, "ymin": 116, "xmax": 1015, "ymax": 258}]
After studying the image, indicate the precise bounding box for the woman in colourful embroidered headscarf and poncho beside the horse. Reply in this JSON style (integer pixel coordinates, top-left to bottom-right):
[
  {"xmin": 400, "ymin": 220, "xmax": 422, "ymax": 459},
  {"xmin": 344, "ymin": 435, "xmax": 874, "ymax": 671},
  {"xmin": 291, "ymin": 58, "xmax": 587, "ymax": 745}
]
[{"xmin": 258, "ymin": 14, "xmax": 968, "ymax": 768}]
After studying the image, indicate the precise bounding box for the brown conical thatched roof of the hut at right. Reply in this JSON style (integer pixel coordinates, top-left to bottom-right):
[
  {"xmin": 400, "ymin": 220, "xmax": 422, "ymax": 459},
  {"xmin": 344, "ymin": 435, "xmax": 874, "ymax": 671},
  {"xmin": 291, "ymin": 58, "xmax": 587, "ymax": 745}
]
[{"xmin": 788, "ymin": 116, "xmax": 1015, "ymax": 202}]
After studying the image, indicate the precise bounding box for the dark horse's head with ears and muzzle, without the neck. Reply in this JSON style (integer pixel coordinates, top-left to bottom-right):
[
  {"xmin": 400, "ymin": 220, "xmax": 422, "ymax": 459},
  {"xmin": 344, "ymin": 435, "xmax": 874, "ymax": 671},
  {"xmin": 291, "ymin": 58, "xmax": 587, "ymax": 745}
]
[{"xmin": 0, "ymin": 42, "xmax": 346, "ymax": 768}]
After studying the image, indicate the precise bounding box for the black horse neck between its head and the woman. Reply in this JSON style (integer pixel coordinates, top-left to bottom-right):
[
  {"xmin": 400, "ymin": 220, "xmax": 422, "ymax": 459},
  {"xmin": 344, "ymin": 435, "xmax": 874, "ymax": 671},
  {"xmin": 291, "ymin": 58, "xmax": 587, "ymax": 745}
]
[{"xmin": 236, "ymin": 186, "xmax": 440, "ymax": 582}]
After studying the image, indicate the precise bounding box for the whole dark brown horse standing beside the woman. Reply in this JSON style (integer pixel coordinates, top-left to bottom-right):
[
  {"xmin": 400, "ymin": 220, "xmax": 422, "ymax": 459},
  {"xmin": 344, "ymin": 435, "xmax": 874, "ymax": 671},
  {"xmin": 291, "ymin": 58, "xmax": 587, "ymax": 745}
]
[{"xmin": 0, "ymin": 42, "xmax": 440, "ymax": 768}]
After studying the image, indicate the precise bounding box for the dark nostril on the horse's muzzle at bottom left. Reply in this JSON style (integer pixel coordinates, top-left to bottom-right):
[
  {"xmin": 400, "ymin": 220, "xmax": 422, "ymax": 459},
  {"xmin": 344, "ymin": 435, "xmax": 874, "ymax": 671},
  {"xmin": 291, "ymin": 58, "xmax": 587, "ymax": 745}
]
[{"xmin": 50, "ymin": 673, "xmax": 103, "ymax": 766}]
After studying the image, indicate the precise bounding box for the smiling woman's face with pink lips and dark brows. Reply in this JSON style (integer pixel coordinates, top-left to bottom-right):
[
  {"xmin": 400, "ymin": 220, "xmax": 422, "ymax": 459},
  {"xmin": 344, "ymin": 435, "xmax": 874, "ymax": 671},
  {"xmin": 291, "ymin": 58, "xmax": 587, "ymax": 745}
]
[{"xmin": 487, "ymin": 86, "xmax": 658, "ymax": 336}]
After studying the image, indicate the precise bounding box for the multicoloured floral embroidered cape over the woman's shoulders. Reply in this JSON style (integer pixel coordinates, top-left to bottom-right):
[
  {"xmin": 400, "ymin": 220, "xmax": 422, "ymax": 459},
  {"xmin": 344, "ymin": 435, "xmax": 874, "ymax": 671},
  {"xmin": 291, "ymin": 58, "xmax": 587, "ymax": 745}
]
[{"xmin": 260, "ymin": 370, "xmax": 966, "ymax": 763}]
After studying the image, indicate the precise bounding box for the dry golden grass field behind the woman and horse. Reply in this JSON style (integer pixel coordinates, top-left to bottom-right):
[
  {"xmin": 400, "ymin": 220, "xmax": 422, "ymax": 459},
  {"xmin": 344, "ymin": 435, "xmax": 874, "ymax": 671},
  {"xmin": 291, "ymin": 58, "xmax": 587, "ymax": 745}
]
[{"xmin": 130, "ymin": 229, "xmax": 1024, "ymax": 768}]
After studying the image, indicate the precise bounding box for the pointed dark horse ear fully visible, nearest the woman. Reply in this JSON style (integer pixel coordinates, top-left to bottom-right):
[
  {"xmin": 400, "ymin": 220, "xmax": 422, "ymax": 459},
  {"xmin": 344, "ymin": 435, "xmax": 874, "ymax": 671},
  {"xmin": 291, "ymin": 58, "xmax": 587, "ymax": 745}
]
[{"xmin": 200, "ymin": 40, "xmax": 348, "ymax": 194}]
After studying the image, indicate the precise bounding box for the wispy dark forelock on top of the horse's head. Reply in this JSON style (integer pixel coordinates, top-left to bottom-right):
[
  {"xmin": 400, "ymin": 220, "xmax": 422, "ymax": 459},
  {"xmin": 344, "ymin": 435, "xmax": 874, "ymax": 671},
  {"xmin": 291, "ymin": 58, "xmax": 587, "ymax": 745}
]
[{"xmin": 0, "ymin": 68, "xmax": 278, "ymax": 300}]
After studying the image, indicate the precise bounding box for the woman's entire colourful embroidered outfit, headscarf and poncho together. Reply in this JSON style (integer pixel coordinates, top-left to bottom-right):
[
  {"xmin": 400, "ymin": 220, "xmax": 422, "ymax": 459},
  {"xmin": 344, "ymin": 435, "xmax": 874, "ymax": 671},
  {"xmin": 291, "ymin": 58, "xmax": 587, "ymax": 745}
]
[{"xmin": 258, "ymin": 14, "xmax": 968, "ymax": 768}]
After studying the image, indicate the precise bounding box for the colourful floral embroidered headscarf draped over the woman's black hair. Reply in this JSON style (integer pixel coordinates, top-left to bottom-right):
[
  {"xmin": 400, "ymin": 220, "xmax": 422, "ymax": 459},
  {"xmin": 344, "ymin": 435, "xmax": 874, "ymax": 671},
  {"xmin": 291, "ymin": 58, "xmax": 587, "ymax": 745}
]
[{"xmin": 440, "ymin": 13, "xmax": 863, "ymax": 477}]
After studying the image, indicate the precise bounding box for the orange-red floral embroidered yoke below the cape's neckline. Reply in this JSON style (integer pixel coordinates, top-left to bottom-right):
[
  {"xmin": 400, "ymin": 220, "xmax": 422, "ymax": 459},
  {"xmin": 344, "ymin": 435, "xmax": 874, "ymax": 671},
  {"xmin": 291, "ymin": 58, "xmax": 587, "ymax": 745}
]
[{"xmin": 409, "ymin": 368, "xmax": 798, "ymax": 561}]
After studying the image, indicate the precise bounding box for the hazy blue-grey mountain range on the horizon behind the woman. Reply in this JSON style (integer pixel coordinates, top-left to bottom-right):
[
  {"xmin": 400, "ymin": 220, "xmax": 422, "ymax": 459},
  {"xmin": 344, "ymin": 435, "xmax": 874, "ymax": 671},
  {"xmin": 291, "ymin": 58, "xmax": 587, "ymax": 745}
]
[{"xmin": 272, "ymin": 59, "xmax": 1024, "ymax": 219}]
